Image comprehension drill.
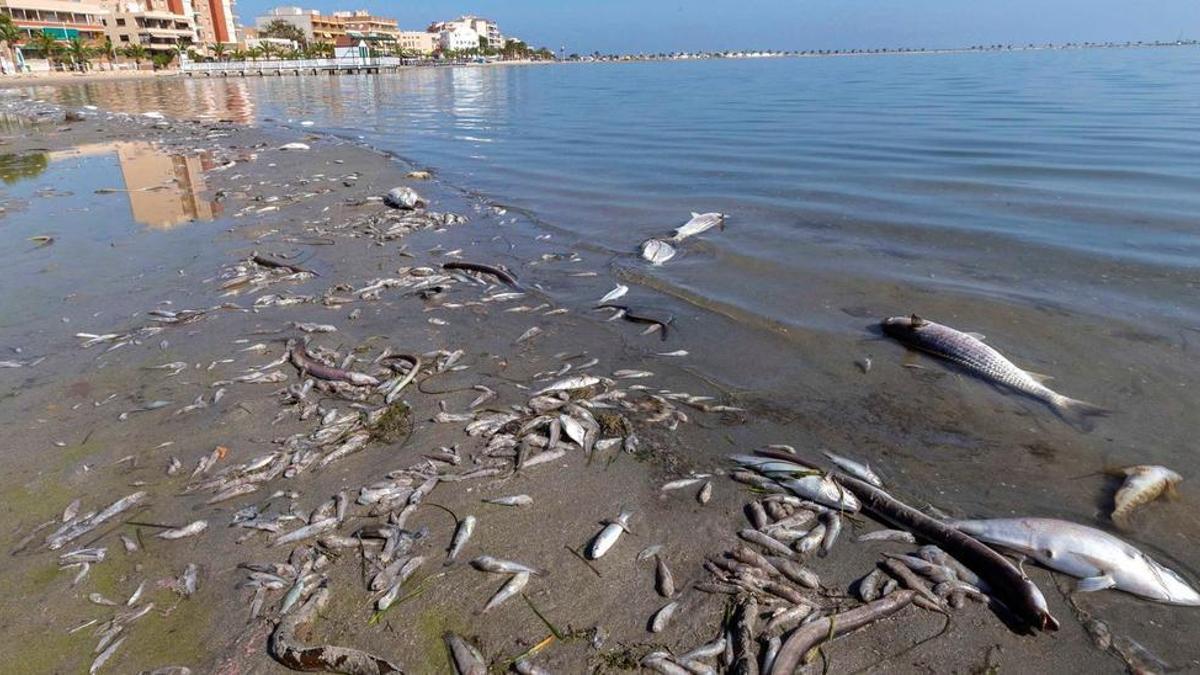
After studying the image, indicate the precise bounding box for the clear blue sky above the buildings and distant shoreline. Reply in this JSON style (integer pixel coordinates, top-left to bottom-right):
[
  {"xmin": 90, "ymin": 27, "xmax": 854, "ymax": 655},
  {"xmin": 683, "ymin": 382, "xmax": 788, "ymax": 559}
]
[{"xmin": 238, "ymin": 0, "xmax": 1200, "ymax": 53}]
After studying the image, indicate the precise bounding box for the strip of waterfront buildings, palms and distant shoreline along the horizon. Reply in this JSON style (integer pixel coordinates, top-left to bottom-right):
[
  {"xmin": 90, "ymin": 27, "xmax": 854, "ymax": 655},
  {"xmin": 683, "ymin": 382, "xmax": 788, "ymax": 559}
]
[{"xmin": 0, "ymin": 0, "xmax": 1198, "ymax": 74}]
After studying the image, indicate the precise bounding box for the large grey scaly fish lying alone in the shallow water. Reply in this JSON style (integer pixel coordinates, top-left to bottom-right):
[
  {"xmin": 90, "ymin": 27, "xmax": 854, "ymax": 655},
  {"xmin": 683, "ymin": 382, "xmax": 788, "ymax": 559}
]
[{"xmin": 882, "ymin": 315, "xmax": 1109, "ymax": 429}]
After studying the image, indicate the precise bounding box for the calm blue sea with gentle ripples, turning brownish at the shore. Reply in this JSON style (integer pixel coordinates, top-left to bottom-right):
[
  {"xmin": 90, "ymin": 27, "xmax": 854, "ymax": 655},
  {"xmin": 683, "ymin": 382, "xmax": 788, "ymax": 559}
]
[{"xmin": 16, "ymin": 48, "xmax": 1200, "ymax": 648}]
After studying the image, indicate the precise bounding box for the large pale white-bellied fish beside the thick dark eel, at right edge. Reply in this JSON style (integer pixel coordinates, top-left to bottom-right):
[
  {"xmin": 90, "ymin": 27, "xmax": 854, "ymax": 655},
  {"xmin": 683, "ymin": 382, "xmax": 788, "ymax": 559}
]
[{"xmin": 948, "ymin": 518, "xmax": 1200, "ymax": 605}]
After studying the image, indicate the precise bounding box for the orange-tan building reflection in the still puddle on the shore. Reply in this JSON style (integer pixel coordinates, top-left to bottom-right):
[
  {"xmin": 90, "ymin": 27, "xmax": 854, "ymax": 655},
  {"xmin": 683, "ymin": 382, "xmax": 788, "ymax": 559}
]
[{"xmin": 45, "ymin": 142, "xmax": 222, "ymax": 229}]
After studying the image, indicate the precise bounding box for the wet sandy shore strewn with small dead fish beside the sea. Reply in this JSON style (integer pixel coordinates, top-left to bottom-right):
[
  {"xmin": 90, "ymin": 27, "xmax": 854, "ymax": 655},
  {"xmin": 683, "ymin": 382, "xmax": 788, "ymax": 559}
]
[{"xmin": 0, "ymin": 97, "xmax": 1166, "ymax": 673}]
